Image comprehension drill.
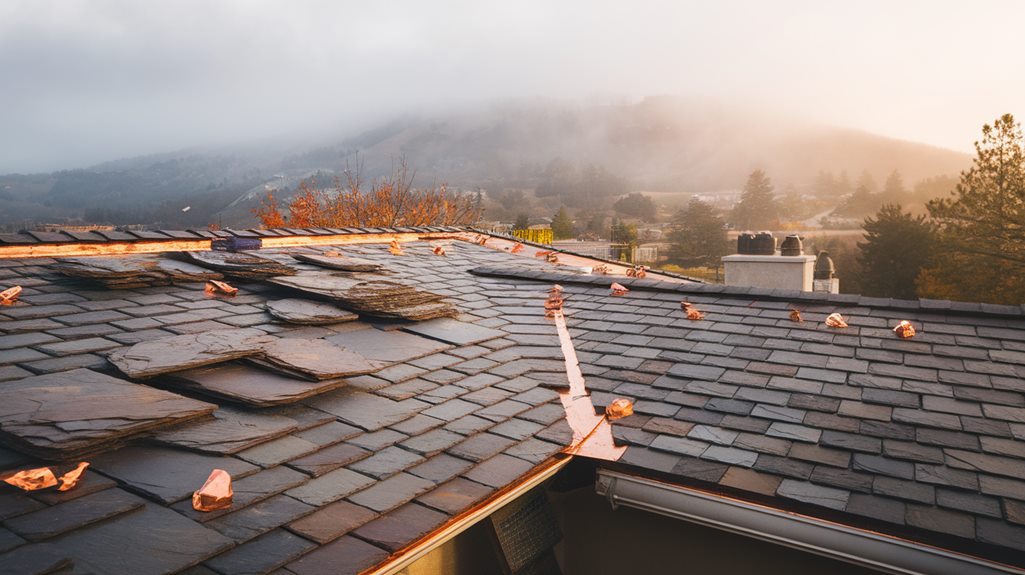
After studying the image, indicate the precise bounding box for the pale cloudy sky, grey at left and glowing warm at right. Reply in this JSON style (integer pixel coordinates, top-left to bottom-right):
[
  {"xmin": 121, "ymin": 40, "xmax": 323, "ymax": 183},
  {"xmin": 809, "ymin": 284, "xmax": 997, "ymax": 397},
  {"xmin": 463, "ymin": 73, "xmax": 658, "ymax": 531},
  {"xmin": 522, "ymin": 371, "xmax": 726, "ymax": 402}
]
[{"xmin": 0, "ymin": 0, "xmax": 1025, "ymax": 173}]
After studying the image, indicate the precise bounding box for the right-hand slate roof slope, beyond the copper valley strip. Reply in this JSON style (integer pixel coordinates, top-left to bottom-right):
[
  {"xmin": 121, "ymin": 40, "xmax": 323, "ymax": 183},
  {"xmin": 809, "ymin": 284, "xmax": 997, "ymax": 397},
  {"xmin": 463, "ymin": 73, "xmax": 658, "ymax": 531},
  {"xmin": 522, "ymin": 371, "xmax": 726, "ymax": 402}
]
[{"xmin": 478, "ymin": 269, "xmax": 1025, "ymax": 566}]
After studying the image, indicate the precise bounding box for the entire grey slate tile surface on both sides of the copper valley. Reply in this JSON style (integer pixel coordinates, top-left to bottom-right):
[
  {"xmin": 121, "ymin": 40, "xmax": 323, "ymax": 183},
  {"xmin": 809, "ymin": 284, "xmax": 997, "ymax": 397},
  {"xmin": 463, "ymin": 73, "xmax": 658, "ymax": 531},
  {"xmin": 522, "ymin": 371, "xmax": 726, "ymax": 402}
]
[{"xmin": 0, "ymin": 233, "xmax": 1025, "ymax": 574}]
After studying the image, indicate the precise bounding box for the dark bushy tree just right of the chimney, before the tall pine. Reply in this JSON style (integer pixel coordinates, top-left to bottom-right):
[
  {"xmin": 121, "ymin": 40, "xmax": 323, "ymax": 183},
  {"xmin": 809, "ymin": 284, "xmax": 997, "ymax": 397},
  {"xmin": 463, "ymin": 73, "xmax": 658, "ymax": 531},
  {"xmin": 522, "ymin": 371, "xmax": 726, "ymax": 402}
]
[{"xmin": 858, "ymin": 204, "xmax": 935, "ymax": 299}]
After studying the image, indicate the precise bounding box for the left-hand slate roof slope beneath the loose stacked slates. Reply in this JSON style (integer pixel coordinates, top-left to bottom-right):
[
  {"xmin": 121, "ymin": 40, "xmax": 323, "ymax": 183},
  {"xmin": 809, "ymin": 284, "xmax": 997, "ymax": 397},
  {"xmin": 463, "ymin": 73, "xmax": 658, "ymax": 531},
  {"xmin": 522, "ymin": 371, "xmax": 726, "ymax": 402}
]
[{"xmin": 0, "ymin": 233, "xmax": 606, "ymax": 575}]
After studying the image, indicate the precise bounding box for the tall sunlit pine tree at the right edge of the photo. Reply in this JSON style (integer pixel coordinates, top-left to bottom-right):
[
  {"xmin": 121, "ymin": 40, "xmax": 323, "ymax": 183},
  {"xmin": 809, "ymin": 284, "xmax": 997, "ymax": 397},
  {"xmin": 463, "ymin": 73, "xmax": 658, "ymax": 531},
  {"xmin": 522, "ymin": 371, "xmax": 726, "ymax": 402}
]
[{"xmin": 919, "ymin": 114, "xmax": 1025, "ymax": 304}]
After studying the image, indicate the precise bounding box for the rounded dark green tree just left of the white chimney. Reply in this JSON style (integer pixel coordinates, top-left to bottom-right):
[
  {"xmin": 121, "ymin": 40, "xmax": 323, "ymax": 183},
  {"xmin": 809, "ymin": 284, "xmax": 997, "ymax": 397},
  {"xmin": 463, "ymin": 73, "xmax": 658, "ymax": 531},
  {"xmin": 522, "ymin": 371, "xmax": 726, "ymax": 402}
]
[{"xmin": 669, "ymin": 198, "xmax": 730, "ymax": 268}]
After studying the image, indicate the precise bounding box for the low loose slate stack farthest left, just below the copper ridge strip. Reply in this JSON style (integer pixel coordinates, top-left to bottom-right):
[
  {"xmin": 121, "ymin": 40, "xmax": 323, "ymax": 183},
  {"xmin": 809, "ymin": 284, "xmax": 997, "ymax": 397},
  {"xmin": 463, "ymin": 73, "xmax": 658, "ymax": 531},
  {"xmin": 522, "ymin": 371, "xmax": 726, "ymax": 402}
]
[{"xmin": 53, "ymin": 255, "xmax": 223, "ymax": 289}]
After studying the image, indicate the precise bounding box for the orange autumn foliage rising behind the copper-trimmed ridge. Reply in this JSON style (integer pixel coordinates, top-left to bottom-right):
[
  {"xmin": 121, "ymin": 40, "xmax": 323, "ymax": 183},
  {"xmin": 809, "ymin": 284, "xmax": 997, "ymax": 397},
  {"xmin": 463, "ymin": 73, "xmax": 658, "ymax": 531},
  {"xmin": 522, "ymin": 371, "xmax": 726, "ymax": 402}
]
[{"xmin": 253, "ymin": 163, "xmax": 479, "ymax": 228}]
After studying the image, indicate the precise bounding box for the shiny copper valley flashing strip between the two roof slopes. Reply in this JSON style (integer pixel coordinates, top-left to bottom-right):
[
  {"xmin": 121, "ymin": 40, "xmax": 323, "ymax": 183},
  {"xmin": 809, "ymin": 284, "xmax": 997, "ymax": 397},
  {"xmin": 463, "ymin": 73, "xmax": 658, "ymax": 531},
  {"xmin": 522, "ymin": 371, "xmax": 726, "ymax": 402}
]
[{"xmin": 554, "ymin": 311, "xmax": 626, "ymax": 461}]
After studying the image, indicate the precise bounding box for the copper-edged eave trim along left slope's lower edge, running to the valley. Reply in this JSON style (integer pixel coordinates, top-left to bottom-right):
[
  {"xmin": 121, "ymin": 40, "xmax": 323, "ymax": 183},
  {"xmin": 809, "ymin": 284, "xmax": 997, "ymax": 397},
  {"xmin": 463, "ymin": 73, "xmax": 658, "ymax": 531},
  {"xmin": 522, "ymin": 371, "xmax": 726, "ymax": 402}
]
[{"xmin": 362, "ymin": 456, "xmax": 573, "ymax": 575}]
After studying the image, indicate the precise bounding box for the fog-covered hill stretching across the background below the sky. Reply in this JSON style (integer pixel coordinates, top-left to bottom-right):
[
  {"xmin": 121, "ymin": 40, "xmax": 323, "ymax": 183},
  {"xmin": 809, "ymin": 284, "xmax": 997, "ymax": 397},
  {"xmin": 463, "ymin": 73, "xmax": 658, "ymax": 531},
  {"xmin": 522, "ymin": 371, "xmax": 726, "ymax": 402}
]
[{"xmin": 0, "ymin": 97, "xmax": 970, "ymax": 227}]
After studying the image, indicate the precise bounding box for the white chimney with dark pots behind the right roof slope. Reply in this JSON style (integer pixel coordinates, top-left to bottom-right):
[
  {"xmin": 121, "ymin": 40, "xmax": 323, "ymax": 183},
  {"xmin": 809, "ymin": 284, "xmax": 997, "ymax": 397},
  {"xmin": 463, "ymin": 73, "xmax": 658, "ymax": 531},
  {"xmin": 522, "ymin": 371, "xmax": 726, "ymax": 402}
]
[{"xmin": 723, "ymin": 232, "xmax": 816, "ymax": 291}]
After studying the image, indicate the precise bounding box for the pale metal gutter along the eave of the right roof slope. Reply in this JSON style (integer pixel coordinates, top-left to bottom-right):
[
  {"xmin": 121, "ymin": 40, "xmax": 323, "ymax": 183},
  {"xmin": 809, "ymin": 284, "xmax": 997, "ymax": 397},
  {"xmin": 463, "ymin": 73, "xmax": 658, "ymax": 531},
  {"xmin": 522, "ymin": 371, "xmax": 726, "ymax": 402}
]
[{"xmin": 595, "ymin": 467, "xmax": 1025, "ymax": 575}]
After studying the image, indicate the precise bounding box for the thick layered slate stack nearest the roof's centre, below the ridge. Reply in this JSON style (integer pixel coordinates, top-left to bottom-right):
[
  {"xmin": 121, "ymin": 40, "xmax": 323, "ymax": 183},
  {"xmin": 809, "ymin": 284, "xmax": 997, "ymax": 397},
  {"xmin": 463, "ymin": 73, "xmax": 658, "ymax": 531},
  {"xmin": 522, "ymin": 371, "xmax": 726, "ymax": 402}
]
[{"xmin": 270, "ymin": 273, "xmax": 457, "ymax": 321}]
